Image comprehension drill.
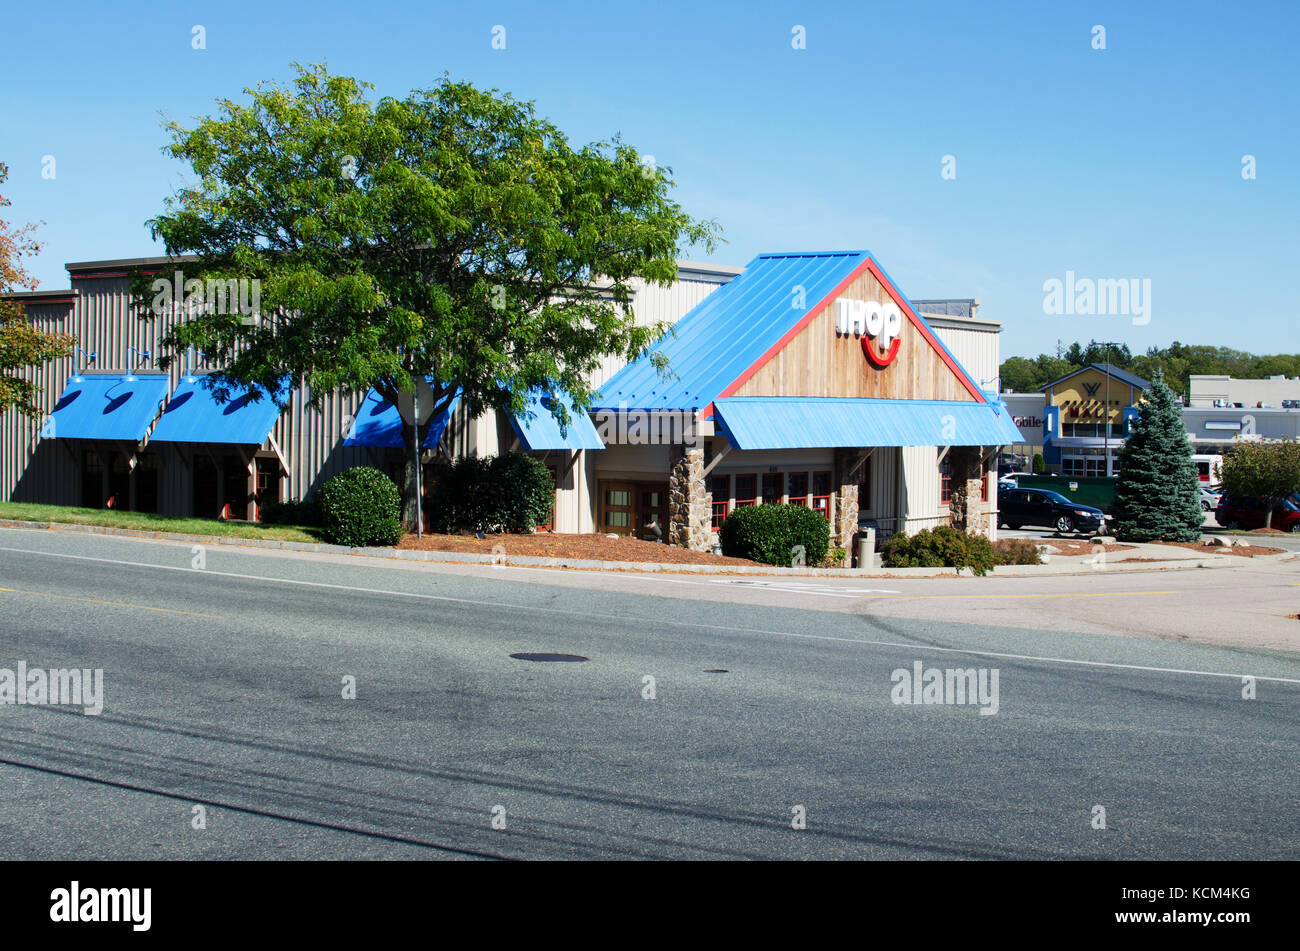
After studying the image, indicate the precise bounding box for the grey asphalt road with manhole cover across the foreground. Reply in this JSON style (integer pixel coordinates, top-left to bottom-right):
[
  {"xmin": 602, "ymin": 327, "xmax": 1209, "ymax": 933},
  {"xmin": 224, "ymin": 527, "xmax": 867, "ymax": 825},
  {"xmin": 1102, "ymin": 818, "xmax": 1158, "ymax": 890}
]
[{"xmin": 0, "ymin": 530, "xmax": 1300, "ymax": 859}]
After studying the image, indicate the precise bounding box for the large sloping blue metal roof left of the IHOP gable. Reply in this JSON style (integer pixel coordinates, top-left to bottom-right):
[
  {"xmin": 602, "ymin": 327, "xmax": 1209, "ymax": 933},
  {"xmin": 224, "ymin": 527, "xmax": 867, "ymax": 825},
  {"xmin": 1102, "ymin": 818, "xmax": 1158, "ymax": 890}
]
[{"xmin": 593, "ymin": 251, "xmax": 871, "ymax": 409}]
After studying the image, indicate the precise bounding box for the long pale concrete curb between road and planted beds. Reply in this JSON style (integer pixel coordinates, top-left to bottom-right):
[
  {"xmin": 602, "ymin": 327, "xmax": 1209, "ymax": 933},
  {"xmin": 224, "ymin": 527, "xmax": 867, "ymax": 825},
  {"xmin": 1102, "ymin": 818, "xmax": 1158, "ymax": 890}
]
[{"xmin": 0, "ymin": 518, "xmax": 1297, "ymax": 578}]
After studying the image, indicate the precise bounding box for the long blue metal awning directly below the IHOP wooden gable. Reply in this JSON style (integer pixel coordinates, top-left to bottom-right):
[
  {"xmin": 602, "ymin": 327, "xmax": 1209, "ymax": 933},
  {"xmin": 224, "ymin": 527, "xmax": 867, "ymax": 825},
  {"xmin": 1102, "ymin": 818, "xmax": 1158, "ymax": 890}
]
[{"xmin": 714, "ymin": 396, "xmax": 1024, "ymax": 450}]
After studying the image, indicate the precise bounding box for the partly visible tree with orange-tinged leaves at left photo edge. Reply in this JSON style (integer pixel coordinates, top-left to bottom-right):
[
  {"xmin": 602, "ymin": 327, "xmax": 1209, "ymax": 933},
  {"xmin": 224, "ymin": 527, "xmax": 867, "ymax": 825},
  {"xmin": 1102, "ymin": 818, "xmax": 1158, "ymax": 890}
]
[{"xmin": 0, "ymin": 162, "xmax": 73, "ymax": 416}]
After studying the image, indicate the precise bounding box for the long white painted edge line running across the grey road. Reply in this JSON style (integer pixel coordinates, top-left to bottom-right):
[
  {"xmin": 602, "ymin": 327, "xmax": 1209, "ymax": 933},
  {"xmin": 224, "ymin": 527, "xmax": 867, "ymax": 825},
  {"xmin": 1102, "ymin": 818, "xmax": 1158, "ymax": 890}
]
[{"xmin": 0, "ymin": 547, "xmax": 1300, "ymax": 685}]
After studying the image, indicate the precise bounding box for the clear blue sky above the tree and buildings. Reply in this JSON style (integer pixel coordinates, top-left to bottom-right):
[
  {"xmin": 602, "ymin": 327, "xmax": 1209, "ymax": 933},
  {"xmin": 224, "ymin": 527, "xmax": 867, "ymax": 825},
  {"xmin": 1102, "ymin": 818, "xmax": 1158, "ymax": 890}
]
[{"xmin": 0, "ymin": 0, "xmax": 1300, "ymax": 356}]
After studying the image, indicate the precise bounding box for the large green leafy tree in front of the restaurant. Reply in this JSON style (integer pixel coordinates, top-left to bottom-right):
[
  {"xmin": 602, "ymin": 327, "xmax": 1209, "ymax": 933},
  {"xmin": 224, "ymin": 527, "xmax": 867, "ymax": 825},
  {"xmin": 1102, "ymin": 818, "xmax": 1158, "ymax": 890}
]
[{"xmin": 137, "ymin": 66, "xmax": 718, "ymax": 525}]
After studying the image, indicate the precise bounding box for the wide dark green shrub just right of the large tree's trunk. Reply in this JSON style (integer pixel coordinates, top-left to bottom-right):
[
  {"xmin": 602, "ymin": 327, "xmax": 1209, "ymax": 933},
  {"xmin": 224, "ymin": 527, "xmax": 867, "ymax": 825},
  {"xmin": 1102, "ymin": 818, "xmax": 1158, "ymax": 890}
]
[{"xmin": 428, "ymin": 452, "xmax": 555, "ymax": 533}]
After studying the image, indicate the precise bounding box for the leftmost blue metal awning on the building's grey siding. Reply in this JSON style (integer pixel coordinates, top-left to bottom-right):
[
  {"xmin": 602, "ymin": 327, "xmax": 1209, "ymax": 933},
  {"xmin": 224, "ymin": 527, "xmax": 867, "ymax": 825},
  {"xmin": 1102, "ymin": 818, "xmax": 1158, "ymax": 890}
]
[{"xmin": 40, "ymin": 373, "xmax": 169, "ymax": 442}]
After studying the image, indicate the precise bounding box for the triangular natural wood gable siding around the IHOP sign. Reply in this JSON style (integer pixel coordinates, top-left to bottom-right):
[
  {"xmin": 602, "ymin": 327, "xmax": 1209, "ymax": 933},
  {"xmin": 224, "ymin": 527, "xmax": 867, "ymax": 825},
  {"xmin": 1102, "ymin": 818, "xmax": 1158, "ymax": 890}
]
[{"xmin": 732, "ymin": 265, "xmax": 974, "ymax": 400}]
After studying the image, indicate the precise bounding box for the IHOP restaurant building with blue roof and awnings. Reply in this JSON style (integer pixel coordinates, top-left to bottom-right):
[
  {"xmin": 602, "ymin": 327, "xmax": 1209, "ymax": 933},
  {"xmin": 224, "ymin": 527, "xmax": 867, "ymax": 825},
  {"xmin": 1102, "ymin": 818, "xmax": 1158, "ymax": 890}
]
[{"xmin": 0, "ymin": 251, "xmax": 1023, "ymax": 548}]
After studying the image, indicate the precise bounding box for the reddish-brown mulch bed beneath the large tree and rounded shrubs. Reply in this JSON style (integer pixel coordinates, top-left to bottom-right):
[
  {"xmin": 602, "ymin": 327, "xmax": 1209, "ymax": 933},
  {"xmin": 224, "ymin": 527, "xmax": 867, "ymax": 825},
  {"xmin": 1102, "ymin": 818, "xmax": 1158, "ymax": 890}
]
[{"xmin": 398, "ymin": 531, "xmax": 758, "ymax": 566}]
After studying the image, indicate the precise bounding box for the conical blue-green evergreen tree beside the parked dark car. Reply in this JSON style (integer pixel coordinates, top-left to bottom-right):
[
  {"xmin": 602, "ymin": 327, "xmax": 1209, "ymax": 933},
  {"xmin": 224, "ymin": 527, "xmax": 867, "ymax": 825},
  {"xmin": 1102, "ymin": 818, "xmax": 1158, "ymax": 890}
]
[{"xmin": 1114, "ymin": 373, "xmax": 1205, "ymax": 542}]
